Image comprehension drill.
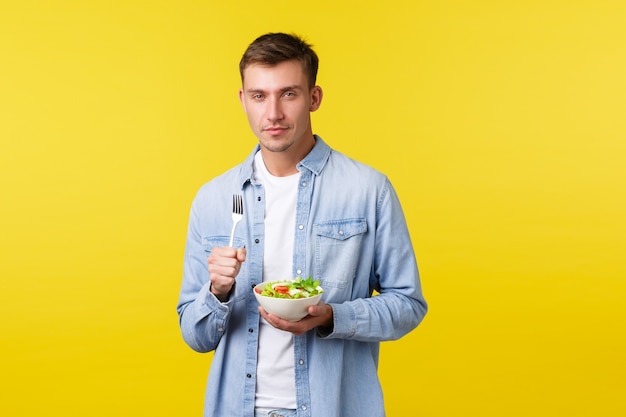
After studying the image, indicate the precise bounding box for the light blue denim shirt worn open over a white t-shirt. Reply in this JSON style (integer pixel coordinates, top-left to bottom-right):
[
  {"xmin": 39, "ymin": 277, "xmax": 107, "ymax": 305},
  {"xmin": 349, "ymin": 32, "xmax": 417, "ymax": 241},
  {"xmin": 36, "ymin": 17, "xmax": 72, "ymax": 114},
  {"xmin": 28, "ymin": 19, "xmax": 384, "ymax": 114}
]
[{"xmin": 177, "ymin": 136, "xmax": 427, "ymax": 417}]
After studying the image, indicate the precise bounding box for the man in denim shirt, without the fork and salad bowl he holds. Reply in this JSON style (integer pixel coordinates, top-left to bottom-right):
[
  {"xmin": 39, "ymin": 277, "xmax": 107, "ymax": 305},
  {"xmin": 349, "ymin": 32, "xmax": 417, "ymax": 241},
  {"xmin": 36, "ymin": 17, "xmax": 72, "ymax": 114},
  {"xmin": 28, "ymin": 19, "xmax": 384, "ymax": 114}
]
[{"xmin": 177, "ymin": 33, "xmax": 427, "ymax": 417}]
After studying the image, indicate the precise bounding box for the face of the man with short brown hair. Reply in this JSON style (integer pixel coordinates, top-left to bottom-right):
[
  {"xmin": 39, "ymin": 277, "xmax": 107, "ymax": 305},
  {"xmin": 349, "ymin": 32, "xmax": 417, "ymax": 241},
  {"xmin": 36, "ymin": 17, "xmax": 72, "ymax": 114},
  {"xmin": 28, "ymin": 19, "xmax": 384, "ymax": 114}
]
[{"xmin": 239, "ymin": 61, "xmax": 322, "ymax": 156}]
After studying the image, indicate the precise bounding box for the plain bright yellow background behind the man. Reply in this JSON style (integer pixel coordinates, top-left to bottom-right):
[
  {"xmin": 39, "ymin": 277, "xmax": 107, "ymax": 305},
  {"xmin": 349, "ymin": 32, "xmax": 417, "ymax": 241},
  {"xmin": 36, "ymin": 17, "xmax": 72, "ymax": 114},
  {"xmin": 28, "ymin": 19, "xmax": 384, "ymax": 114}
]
[{"xmin": 0, "ymin": 0, "xmax": 626, "ymax": 417}]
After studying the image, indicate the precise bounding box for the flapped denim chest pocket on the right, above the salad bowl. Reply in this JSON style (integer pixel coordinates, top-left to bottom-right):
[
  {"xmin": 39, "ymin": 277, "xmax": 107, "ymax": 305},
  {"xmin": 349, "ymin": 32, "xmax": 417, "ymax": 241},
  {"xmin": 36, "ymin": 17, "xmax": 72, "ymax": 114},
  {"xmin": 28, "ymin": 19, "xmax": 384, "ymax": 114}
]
[{"xmin": 313, "ymin": 219, "xmax": 367, "ymax": 292}]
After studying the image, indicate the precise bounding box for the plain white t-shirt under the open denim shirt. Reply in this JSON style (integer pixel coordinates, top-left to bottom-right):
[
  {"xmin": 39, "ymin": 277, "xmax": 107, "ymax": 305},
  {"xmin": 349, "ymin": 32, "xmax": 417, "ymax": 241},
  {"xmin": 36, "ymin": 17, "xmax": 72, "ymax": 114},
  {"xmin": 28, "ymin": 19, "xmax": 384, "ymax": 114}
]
[{"xmin": 254, "ymin": 152, "xmax": 300, "ymax": 409}]
